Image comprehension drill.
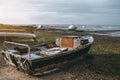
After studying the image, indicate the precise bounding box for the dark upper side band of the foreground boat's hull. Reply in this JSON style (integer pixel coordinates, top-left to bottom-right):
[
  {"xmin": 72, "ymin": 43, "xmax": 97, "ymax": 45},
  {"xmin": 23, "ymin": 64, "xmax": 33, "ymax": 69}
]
[{"xmin": 31, "ymin": 44, "xmax": 91, "ymax": 69}]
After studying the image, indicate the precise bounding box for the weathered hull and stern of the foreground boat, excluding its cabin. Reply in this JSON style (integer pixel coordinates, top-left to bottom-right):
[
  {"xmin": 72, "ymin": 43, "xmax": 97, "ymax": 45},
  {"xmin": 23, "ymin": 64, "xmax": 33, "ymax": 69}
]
[{"xmin": 2, "ymin": 37, "xmax": 94, "ymax": 75}]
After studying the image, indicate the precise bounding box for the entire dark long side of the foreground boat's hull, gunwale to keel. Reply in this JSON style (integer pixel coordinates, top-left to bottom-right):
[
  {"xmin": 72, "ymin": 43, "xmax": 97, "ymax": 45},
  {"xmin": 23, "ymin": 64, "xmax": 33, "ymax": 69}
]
[{"xmin": 32, "ymin": 44, "xmax": 92, "ymax": 75}]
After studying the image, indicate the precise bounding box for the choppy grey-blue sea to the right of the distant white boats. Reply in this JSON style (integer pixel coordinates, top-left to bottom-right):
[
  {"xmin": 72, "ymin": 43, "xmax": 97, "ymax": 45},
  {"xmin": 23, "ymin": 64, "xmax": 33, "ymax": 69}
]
[{"xmin": 78, "ymin": 25, "xmax": 120, "ymax": 37}]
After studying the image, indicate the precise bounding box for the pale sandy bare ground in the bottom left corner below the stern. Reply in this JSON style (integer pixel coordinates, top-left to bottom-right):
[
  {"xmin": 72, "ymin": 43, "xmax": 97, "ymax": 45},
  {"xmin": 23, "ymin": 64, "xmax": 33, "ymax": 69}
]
[{"xmin": 0, "ymin": 66, "xmax": 38, "ymax": 80}]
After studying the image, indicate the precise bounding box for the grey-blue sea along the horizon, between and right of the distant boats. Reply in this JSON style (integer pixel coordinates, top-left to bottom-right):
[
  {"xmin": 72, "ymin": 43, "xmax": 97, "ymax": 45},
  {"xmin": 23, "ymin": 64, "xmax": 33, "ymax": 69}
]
[{"xmin": 43, "ymin": 24, "xmax": 120, "ymax": 37}]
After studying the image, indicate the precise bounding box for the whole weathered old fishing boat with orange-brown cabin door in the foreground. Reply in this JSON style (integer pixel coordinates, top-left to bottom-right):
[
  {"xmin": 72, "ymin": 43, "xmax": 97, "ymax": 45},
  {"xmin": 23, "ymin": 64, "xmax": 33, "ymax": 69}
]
[{"xmin": 1, "ymin": 36, "xmax": 94, "ymax": 75}]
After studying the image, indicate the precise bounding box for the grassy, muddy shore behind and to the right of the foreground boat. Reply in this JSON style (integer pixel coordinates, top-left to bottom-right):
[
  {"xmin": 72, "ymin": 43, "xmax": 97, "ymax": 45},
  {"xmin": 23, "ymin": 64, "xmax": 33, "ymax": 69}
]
[{"xmin": 0, "ymin": 26, "xmax": 120, "ymax": 80}]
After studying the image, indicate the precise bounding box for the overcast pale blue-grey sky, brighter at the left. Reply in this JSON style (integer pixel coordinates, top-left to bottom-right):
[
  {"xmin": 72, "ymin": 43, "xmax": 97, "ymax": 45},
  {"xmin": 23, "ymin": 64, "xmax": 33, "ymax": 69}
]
[{"xmin": 0, "ymin": 0, "xmax": 120, "ymax": 25}]
